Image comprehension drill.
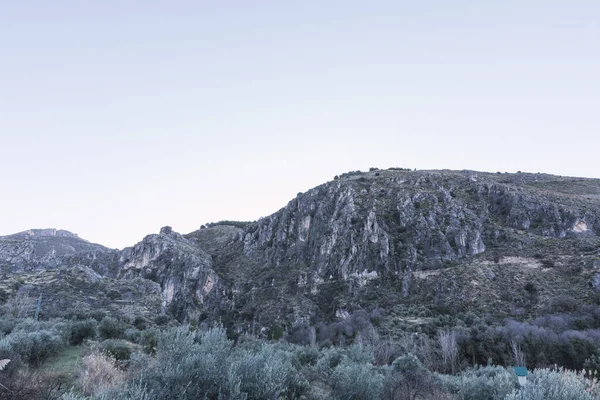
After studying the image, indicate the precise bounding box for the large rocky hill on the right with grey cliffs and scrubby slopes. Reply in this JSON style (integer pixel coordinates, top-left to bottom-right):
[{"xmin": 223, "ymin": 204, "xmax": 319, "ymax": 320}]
[{"xmin": 188, "ymin": 170, "xmax": 600, "ymax": 332}]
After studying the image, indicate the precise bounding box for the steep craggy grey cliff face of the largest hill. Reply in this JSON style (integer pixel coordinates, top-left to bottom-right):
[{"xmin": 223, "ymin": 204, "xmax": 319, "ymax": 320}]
[{"xmin": 234, "ymin": 171, "xmax": 600, "ymax": 287}]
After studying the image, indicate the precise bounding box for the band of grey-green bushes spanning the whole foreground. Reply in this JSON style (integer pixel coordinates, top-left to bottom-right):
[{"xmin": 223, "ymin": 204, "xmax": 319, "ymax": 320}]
[{"xmin": 0, "ymin": 318, "xmax": 600, "ymax": 400}]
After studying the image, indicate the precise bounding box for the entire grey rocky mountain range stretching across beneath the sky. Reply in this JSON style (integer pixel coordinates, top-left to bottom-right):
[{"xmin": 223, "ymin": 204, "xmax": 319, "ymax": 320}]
[{"xmin": 0, "ymin": 169, "xmax": 600, "ymax": 338}]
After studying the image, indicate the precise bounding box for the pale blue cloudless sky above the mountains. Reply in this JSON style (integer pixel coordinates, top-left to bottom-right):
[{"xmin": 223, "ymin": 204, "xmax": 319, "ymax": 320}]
[{"xmin": 0, "ymin": 0, "xmax": 600, "ymax": 248}]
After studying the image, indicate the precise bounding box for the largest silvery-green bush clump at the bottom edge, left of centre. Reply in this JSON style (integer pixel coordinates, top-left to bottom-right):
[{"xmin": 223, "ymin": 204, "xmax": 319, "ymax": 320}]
[{"xmin": 99, "ymin": 328, "xmax": 308, "ymax": 400}]
